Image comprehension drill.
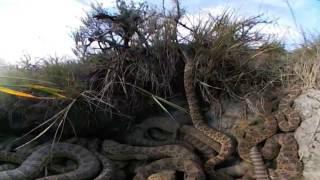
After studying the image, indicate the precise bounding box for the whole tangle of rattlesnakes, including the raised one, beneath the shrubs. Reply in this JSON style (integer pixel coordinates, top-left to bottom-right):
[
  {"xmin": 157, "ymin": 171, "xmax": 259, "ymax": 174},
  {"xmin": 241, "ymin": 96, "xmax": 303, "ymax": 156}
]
[{"xmin": 0, "ymin": 70, "xmax": 302, "ymax": 180}]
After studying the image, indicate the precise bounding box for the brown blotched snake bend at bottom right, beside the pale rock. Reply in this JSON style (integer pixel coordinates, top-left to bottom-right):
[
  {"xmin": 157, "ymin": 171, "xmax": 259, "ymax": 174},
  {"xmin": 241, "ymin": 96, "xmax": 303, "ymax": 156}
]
[{"xmin": 261, "ymin": 133, "xmax": 303, "ymax": 179}]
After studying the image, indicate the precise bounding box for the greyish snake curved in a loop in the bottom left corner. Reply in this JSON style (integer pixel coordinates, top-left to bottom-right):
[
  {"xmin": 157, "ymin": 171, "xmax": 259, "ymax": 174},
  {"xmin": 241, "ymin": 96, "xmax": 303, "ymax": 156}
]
[{"xmin": 0, "ymin": 143, "xmax": 100, "ymax": 180}]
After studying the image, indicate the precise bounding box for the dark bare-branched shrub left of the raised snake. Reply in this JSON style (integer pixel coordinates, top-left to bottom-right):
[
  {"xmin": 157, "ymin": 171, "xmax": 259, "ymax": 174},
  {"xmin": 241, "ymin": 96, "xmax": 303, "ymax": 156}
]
[{"xmin": 74, "ymin": 1, "xmax": 183, "ymax": 112}]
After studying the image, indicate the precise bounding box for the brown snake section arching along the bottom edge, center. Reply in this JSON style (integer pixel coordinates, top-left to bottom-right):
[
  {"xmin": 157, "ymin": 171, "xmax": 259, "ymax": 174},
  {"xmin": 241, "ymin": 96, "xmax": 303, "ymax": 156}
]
[{"xmin": 133, "ymin": 158, "xmax": 206, "ymax": 180}]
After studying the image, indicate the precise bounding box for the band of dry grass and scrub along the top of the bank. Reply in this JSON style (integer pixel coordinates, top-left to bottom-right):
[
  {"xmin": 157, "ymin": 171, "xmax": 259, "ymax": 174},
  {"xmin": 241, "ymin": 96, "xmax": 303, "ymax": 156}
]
[{"xmin": 0, "ymin": 1, "xmax": 320, "ymax": 142}]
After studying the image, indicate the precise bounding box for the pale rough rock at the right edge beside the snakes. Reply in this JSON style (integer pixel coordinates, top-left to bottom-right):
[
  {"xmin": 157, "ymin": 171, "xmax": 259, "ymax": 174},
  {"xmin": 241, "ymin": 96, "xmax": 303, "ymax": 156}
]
[{"xmin": 294, "ymin": 89, "xmax": 320, "ymax": 180}]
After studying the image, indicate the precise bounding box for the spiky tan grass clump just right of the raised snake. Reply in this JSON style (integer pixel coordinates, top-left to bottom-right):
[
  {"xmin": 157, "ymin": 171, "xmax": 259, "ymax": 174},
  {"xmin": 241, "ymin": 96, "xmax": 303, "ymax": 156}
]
[{"xmin": 181, "ymin": 11, "xmax": 284, "ymax": 102}]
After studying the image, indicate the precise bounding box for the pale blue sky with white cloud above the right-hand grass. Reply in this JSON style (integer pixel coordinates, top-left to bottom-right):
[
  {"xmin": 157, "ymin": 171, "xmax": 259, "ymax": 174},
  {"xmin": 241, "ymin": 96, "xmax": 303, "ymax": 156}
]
[{"xmin": 147, "ymin": 0, "xmax": 320, "ymax": 47}]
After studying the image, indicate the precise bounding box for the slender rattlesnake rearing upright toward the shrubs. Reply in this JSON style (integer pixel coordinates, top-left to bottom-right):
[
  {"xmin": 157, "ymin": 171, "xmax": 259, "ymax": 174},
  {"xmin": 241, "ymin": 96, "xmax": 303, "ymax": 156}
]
[{"xmin": 184, "ymin": 53, "xmax": 234, "ymax": 169}]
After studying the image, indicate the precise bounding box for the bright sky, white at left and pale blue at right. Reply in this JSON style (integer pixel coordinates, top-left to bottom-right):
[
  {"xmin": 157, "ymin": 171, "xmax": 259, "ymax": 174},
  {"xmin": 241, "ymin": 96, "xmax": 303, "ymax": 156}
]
[{"xmin": 0, "ymin": 0, "xmax": 320, "ymax": 64}]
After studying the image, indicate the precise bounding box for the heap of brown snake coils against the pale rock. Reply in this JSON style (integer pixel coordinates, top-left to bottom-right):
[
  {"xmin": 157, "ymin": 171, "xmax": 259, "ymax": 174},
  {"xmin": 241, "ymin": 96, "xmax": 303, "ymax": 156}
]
[{"xmin": 235, "ymin": 87, "xmax": 302, "ymax": 179}]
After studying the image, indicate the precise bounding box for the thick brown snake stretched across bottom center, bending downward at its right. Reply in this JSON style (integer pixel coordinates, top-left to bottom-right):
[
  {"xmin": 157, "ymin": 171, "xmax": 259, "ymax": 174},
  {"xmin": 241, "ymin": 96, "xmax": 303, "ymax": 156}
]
[{"xmin": 102, "ymin": 140, "xmax": 205, "ymax": 180}]
